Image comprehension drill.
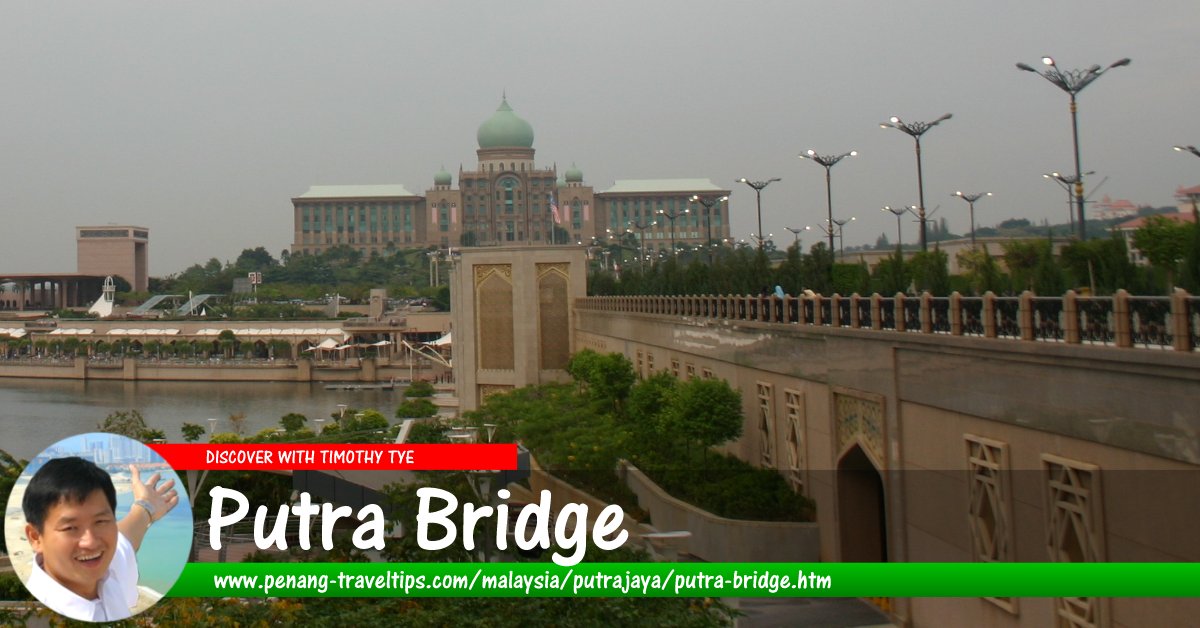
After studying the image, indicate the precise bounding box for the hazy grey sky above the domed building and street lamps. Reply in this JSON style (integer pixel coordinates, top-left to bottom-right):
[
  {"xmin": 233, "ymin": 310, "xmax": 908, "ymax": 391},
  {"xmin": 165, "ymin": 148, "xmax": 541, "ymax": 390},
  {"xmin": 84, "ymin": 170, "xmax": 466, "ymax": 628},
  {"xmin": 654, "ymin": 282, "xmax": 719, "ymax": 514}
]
[{"xmin": 0, "ymin": 0, "xmax": 1200, "ymax": 276}]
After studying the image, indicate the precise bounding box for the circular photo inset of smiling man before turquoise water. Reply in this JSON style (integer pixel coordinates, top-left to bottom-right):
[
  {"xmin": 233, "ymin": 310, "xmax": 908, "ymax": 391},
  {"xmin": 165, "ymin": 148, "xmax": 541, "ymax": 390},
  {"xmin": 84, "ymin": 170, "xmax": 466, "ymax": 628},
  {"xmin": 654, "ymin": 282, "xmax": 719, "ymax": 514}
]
[{"xmin": 4, "ymin": 432, "xmax": 192, "ymax": 622}]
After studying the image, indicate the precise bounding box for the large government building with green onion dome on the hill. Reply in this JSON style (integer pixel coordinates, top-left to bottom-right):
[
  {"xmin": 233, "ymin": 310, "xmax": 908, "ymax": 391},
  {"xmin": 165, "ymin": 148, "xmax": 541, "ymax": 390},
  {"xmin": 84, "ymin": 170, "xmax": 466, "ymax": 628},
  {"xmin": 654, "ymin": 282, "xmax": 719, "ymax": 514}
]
[{"xmin": 292, "ymin": 98, "xmax": 730, "ymax": 253}]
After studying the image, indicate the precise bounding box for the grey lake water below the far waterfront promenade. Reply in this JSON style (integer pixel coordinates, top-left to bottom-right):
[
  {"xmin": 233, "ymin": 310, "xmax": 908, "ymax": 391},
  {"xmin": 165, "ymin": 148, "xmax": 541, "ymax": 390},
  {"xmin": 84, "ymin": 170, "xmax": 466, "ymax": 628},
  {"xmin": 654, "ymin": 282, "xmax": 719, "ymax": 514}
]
[{"xmin": 0, "ymin": 378, "xmax": 402, "ymax": 460}]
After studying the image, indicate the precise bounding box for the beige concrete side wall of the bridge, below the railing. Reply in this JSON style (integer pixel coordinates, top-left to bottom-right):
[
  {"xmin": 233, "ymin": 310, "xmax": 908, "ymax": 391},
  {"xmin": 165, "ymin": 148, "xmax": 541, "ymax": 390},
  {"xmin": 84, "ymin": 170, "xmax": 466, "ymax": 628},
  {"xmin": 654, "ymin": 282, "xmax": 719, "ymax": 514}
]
[{"xmin": 574, "ymin": 303, "xmax": 1200, "ymax": 626}]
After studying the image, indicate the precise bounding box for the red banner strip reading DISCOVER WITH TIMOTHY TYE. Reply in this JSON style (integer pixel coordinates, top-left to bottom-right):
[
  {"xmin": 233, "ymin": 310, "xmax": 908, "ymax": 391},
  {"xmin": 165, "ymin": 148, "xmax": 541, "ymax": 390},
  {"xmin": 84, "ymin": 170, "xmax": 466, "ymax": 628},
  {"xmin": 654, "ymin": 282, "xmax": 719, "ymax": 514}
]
[{"xmin": 149, "ymin": 443, "xmax": 517, "ymax": 471}]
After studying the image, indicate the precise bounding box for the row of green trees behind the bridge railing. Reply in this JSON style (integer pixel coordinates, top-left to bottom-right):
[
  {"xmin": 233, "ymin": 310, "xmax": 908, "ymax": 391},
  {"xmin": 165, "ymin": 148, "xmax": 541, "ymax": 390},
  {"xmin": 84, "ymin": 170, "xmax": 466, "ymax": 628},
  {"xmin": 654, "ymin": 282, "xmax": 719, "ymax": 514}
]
[{"xmin": 588, "ymin": 222, "xmax": 1200, "ymax": 295}]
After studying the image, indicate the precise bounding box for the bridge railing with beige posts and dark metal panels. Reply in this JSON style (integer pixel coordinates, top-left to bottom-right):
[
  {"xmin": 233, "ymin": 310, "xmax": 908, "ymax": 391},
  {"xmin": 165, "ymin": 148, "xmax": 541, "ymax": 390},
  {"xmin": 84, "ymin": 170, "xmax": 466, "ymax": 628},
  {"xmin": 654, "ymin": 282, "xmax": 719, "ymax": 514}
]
[{"xmin": 576, "ymin": 289, "xmax": 1200, "ymax": 352}]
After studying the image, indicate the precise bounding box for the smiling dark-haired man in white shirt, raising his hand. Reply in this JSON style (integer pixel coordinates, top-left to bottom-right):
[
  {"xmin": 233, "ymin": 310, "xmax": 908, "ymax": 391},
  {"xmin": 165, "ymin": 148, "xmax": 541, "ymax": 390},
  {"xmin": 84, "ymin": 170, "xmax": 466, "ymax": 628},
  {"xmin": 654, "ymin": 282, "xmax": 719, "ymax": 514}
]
[{"xmin": 22, "ymin": 457, "xmax": 179, "ymax": 622}]
